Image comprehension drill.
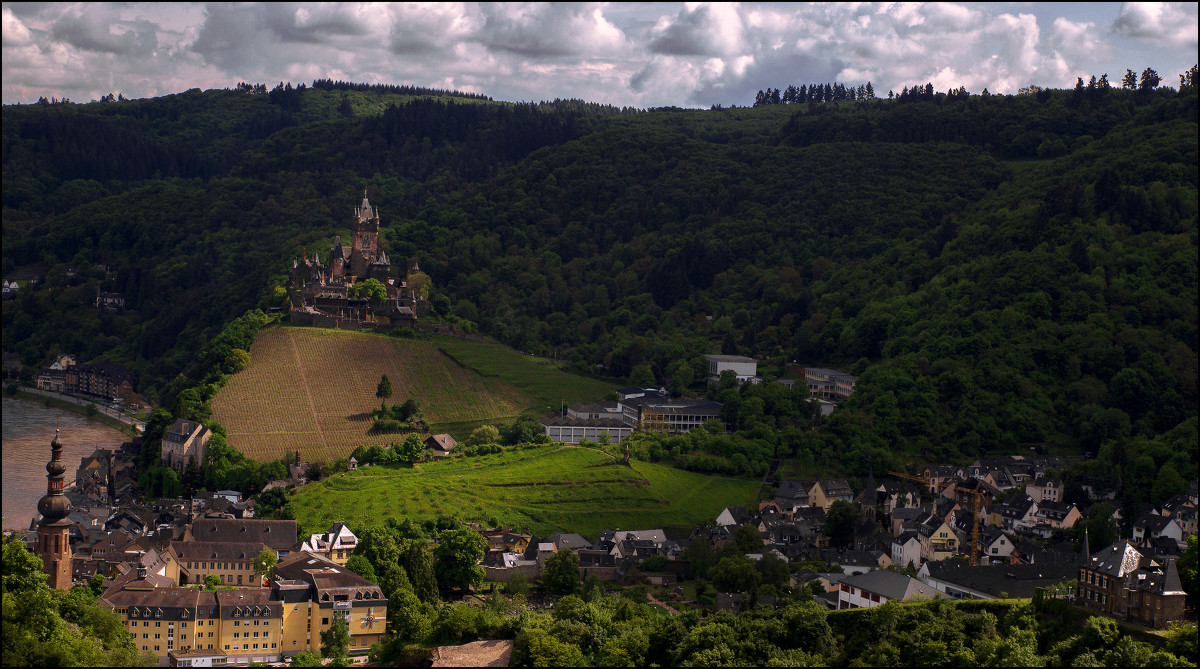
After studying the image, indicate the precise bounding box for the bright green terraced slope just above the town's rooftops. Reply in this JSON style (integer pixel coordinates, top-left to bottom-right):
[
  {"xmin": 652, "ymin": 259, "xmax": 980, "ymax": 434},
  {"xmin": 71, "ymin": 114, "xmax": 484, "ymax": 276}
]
[{"xmin": 293, "ymin": 446, "xmax": 760, "ymax": 541}]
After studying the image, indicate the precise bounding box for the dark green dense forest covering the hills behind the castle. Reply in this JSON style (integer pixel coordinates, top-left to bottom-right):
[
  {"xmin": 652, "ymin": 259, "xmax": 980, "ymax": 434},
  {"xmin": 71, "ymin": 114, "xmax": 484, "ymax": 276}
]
[{"xmin": 2, "ymin": 76, "xmax": 1198, "ymax": 495}]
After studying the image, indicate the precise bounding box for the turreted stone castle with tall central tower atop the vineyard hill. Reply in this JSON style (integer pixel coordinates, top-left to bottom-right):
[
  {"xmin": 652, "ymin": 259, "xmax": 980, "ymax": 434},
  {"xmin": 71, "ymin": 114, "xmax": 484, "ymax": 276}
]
[{"xmin": 288, "ymin": 189, "xmax": 430, "ymax": 330}]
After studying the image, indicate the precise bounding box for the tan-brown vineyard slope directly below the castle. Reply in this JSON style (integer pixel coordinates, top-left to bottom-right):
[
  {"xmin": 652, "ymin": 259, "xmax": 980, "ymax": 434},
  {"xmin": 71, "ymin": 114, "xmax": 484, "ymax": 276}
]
[{"xmin": 212, "ymin": 327, "xmax": 535, "ymax": 462}]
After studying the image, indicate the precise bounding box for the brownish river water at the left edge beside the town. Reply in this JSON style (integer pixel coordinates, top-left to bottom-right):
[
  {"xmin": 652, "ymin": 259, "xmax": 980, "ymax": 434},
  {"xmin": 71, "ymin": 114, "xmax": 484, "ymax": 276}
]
[{"xmin": 0, "ymin": 397, "xmax": 128, "ymax": 530}]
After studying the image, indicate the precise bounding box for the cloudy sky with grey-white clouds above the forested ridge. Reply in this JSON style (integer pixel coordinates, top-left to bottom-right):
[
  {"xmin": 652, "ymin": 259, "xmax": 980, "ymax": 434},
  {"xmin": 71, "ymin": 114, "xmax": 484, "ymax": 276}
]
[{"xmin": 2, "ymin": 2, "xmax": 1196, "ymax": 107}]
